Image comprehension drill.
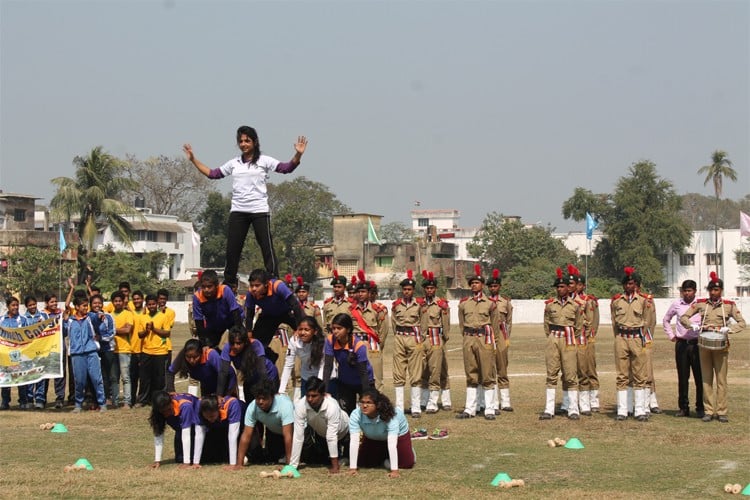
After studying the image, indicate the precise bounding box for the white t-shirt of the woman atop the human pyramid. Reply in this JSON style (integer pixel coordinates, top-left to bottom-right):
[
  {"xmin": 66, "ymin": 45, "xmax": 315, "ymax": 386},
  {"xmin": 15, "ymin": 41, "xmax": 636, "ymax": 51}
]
[{"xmin": 219, "ymin": 155, "xmax": 280, "ymax": 213}]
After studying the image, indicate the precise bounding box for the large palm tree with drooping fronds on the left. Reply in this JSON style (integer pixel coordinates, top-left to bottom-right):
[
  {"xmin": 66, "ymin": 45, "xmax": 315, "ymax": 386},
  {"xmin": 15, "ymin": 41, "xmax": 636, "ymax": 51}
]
[{"xmin": 50, "ymin": 146, "xmax": 138, "ymax": 250}]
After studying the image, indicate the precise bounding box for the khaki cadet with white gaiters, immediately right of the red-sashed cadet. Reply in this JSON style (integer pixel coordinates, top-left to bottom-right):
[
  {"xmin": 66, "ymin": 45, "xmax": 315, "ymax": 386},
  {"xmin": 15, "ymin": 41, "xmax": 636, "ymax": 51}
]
[{"xmin": 391, "ymin": 269, "xmax": 425, "ymax": 418}]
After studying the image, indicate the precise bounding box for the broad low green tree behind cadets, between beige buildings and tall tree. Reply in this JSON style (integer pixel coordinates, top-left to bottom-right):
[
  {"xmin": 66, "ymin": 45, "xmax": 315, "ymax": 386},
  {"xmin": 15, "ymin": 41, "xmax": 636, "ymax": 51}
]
[{"xmin": 467, "ymin": 212, "xmax": 576, "ymax": 272}]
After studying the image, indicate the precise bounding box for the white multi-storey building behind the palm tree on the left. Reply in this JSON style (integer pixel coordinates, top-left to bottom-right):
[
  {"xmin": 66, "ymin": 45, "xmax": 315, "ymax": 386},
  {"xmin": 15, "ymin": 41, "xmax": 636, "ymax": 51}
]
[{"xmin": 95, "ymin": 211, "xmax": 201, "ymax": 280}]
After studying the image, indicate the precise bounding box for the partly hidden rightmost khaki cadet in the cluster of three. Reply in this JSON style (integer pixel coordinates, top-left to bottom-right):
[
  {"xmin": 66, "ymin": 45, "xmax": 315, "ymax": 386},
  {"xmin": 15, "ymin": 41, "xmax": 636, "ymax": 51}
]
[{"xmin": 576, "ymin": 274, "xmax": 599, "ymax": 415}]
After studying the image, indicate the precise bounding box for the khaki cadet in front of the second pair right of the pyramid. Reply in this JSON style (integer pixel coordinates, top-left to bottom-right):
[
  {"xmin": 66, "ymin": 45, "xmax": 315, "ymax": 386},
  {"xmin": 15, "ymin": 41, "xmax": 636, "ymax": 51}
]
[{"xmin": 456, "ymin": 265, "xmax": 497, "ymax": 420}]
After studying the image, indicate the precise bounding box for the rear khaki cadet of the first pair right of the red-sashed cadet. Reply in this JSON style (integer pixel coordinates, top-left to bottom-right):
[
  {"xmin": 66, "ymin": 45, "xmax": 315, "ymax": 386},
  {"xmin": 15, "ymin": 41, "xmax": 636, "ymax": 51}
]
[{"xmin": 417, "ymin": 270, "xmax": 452, "ymax": 414}]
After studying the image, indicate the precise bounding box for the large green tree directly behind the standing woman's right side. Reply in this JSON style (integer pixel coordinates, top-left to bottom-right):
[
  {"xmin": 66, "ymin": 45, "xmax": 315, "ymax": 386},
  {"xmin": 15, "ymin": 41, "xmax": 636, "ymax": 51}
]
[{"xmin": 270, "ymin": 177, "xmax": 351, "ymax": 280}]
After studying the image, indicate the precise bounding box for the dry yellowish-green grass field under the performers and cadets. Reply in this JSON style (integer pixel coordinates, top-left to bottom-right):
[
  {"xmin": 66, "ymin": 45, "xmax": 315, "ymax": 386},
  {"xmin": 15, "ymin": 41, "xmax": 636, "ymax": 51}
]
[{"xmin": 0, "ymin": 325, "xmax": 750, "ymax": 499}]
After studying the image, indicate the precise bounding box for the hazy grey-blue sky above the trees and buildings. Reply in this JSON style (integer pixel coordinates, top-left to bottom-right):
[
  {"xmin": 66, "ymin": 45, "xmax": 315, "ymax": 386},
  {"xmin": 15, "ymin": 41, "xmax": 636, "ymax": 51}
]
[{"xmin": 0, "ymin": 0, "xmax": 750, "ymax": 230}]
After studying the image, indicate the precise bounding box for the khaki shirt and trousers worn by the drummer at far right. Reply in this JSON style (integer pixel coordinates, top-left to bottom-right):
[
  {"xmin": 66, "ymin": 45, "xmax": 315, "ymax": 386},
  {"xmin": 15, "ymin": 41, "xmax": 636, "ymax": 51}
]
[{"xmin": 680, "ymin": 299, "xmax": 747, "ymax": 416}]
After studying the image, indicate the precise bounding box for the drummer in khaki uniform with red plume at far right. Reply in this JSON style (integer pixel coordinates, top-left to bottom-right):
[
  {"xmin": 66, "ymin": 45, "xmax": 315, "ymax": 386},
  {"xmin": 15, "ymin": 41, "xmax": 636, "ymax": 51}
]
[{"xmin": 680, "ymin": 271, "xmax": 745, "ymax": 423}]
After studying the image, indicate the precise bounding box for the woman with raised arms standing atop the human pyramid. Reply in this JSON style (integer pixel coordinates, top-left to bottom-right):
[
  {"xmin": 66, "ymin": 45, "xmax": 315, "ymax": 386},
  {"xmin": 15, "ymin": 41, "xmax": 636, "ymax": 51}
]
[{"xmin": 183, "ymin": 125, "xmax": 307, "ymax": 285}]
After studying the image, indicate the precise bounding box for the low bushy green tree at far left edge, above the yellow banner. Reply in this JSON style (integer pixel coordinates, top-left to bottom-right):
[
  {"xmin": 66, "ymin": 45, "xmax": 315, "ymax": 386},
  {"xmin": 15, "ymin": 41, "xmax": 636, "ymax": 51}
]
[{"xmin": 0, "ymin": 246, "xmax": 75, "ymax": 300}]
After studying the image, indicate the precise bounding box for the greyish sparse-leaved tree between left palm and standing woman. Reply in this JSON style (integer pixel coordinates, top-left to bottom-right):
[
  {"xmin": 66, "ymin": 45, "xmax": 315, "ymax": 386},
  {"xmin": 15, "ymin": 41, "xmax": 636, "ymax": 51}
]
[{"xmin": 123, "ymin": 156, "xmax": 216, "ymax": 222}]
